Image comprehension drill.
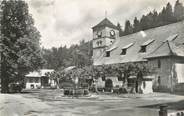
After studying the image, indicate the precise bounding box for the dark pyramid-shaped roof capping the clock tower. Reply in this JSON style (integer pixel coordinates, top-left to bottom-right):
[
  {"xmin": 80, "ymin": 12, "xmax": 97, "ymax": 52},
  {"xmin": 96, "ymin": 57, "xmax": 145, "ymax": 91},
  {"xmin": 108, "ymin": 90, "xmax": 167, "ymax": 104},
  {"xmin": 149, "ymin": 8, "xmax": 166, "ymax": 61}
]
[{"xmin": 92, "ymin": 18, "xmax": 117, "ymax": 29}]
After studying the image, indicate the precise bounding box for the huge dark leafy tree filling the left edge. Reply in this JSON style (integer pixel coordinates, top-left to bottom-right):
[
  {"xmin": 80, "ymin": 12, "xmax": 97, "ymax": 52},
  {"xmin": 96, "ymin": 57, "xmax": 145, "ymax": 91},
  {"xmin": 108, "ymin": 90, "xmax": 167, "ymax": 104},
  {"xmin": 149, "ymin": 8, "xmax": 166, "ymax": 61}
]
[{"xmin": 0, "ymin": 0, "xmax": 44, "ymax": 93}]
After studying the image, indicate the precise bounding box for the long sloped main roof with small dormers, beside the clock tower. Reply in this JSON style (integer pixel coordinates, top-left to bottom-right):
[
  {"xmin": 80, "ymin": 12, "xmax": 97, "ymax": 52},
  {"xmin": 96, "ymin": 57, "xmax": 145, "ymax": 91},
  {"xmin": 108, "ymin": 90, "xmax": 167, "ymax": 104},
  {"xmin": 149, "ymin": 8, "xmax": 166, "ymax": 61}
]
[{"xmin": 94, "ymin": 21, "xmax": 184, "ymax": 65}]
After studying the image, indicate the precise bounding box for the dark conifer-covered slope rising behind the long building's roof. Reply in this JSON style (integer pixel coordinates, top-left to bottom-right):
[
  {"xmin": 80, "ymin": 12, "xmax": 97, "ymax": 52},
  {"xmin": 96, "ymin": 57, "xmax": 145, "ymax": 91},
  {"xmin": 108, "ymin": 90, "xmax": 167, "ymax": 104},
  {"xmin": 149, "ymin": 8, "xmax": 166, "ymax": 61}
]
[{"xmin": 117, "ymin": 0, "xmax": 184, "ymax": 36}]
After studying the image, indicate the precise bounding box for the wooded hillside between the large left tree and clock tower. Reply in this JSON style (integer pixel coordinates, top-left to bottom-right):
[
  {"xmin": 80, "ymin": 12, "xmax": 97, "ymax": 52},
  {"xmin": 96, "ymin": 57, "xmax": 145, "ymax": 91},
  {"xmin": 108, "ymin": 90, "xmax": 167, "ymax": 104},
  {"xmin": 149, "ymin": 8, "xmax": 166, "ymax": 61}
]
[{"xmin": 43, "ymin": 40, "xmax": 92, "ymax": 70}]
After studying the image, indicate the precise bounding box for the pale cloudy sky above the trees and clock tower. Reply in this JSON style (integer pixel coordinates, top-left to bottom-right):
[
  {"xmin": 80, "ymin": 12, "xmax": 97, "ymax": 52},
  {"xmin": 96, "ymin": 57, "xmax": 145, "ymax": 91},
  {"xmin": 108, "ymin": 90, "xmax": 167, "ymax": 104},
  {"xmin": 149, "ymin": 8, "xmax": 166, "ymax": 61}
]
[{"xmin": 27, "ymin": 0, "xmax": 184, "ymax": 48}]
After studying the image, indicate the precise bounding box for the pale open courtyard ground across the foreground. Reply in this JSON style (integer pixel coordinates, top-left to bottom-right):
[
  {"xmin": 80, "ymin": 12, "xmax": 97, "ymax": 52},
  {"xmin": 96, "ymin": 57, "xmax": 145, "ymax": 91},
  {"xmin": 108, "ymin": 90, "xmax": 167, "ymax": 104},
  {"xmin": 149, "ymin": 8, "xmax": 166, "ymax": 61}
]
[{"xmin": 0, "ymin": 89, "xmax": 184, "ymax": 116}]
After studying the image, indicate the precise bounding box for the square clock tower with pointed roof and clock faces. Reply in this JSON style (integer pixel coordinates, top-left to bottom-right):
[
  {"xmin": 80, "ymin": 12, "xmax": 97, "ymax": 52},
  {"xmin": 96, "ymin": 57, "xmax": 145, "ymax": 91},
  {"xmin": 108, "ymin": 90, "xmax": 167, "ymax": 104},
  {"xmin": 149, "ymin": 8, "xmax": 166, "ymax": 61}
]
[{"xmin": 92, "ymin": 18, "xmax": 119, "ymax": 60}]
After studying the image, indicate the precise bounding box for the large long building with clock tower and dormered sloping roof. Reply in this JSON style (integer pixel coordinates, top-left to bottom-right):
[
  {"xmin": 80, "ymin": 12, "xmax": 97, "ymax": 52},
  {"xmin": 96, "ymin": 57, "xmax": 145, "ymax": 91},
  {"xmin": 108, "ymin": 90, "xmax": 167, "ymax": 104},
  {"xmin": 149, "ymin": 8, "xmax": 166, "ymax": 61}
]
[{"xmin": 92, "ymin": 18, "xmax": 184, "ymax": 91}]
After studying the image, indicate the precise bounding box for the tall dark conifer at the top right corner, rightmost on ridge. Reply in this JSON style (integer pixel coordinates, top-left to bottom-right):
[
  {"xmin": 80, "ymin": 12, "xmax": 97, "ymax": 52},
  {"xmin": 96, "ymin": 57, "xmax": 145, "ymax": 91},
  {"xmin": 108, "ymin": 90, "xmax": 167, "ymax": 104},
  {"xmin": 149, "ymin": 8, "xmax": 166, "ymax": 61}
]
[{"xmin": 174, "ymin": 0, "xmax": 184, "ymax": 21}]
